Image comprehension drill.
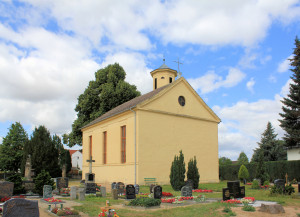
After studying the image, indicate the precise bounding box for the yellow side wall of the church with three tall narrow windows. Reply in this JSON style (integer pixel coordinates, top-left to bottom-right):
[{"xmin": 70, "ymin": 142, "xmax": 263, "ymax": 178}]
[{"xmin": 82, "ymin": 111, "xmax": 139, "ymax": 183}]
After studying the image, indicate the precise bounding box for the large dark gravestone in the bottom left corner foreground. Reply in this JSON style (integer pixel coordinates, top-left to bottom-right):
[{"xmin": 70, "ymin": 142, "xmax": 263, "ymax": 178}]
[{"xmin": 3, "ymin": 198, "xmax": 40, "ymax": 217}]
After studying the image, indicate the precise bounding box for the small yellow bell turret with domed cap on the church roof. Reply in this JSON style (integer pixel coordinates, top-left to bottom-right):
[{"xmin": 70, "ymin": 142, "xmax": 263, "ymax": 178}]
[{"xmin": 150, "ymin": 63, "xmax": 177, "ymax": 90}]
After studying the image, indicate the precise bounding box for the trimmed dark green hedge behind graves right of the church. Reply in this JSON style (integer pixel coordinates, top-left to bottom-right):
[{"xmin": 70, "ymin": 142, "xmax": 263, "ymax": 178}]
[{"xmin": 219, "ymin": 160, "xmax": 300, "ymax": 182}]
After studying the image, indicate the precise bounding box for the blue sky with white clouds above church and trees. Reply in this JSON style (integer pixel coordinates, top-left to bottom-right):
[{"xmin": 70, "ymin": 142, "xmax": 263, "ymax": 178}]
[{"xmin": 0, "ymin": 0, "xmax": 300, "ymax": 160}]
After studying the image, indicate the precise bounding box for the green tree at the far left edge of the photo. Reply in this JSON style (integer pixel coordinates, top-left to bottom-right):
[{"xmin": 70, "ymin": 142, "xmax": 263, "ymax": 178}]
[{"xmin": 0, "ymin": 122, "xmax": 28, "ymax": 172}]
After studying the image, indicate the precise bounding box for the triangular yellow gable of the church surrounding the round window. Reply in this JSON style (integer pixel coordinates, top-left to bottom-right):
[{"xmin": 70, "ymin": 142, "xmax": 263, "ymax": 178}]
[{"xmin": 141, "ymin": 78, "xmax": 219, "ymax": 122}]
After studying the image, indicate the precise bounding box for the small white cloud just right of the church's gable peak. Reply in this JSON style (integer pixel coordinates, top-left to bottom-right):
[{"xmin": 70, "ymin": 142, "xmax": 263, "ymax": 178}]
[{"xmin": 188, "ymin": 68, "xmax": 246, "ymax": 94}]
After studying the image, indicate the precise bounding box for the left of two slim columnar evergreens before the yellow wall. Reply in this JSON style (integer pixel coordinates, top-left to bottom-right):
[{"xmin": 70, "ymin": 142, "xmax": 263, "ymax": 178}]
[{"xmin": 170, "ymin": 151, "xmax": 185, "ymax": 191}]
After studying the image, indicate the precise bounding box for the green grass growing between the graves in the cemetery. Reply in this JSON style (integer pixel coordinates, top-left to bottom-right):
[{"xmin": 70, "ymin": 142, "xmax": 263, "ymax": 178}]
[{"xmin": 69, "ymin": 181, "xmax": 300, "ymax": 217}]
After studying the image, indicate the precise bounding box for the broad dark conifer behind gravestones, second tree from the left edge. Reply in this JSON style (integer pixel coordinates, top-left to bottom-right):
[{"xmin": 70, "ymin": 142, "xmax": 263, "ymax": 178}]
[{"xmin": 22, "ymin": 126, "xmax": 61, "ymax": 177}]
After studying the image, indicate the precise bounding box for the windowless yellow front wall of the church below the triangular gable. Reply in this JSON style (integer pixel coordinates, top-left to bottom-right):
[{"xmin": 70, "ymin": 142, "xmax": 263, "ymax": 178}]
[{"xmin": 138, "ymin": 111, "xmax": 219, "ymax": 184}]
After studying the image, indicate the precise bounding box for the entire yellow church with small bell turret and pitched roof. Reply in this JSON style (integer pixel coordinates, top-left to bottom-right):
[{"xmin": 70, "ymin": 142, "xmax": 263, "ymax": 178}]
[{"xmin": 82, "ymin": 64, "xmax": 221, "ymax": 185}]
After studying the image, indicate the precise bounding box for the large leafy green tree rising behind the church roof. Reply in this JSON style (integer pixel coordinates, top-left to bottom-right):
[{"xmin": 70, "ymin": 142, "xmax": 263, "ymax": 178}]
[{"xmin": 63, "ymin": 63, "xmax": 141, "ymax": 147}]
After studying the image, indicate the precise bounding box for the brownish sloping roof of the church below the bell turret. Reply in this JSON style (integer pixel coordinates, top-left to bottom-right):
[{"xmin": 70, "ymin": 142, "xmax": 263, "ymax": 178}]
[{"xmin": 81, "ymin": 82, "xmax": 176, "ymax": 129}]
